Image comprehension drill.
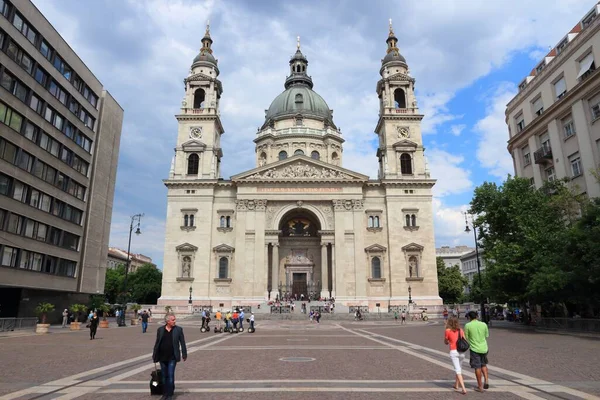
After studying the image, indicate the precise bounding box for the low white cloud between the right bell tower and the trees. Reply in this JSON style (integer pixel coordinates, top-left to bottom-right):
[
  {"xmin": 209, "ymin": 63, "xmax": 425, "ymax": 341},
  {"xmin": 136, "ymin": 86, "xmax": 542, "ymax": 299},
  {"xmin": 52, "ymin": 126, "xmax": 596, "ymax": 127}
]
[{"xmin": 427, "ymin": 149, "xmax": 473, "ymax": 197}]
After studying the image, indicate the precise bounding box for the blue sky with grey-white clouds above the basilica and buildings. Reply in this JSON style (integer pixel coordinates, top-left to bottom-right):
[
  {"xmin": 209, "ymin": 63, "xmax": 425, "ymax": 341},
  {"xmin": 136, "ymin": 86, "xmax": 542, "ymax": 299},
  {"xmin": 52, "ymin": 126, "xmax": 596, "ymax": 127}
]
[{"xmin": 33, "ymin": 0, "xmax": 596, "ymax": 266}]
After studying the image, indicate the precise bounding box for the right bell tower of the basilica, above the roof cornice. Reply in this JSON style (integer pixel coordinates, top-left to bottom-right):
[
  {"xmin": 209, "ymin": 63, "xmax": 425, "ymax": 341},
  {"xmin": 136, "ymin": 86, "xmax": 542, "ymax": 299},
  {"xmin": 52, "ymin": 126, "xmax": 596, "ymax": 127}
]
[{"xmin": 375, "ymin": 19, "xmax": 429, "ymax": 179}]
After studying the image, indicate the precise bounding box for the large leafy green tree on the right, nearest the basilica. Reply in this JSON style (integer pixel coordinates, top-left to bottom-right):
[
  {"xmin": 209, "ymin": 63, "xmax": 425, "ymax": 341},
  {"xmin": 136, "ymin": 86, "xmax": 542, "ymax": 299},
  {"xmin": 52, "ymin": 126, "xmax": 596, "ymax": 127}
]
[{"xmin": 470, "ymin": 177, "xmax": 572, "ymax": 306}]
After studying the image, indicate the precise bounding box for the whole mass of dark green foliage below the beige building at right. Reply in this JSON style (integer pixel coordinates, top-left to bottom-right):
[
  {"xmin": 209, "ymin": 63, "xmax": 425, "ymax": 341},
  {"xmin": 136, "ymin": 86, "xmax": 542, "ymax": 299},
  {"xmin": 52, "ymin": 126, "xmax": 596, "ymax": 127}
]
[{"xmin": 470, "ymin": 177, "xmax": 600, "ymax": 316}]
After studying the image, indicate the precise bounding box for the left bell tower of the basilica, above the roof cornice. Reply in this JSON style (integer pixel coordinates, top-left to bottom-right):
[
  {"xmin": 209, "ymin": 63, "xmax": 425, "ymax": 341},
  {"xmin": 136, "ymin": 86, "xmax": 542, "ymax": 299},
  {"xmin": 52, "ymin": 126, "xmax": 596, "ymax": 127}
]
[{"xmin": 169, "ymin": 23, "xmax": 224, "ymax": 179}]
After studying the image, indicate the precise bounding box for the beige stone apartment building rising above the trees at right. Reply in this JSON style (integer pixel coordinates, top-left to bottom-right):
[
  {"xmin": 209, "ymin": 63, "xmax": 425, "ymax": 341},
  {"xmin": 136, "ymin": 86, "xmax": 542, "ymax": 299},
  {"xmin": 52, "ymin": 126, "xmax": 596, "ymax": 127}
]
[{"xmin": 506, "ymin": 4, "xmax": 600, "ymax": 197}]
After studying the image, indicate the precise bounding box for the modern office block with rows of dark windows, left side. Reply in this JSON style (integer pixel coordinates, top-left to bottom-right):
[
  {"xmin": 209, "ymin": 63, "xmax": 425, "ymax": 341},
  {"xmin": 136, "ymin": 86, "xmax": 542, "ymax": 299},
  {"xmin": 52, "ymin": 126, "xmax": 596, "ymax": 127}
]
[{"xmin": 0, "ymin": 0, "xmax": 123, "ymax": 317}]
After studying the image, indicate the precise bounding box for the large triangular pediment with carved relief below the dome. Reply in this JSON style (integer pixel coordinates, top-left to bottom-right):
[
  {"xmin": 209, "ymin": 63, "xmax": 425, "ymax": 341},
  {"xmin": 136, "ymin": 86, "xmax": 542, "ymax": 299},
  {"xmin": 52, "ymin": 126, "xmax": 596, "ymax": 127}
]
[{"xmin": 231, "ymin": 155, "xmax": 369, "ymax": 182}]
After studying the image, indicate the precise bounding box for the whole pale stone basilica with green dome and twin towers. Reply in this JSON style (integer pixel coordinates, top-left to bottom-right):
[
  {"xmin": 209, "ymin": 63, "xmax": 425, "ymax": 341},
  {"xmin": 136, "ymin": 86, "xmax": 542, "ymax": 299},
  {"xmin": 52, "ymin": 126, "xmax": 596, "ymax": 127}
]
[{"xmin": 159, "ymin": 26, "xmax": 441, "ymax": 310}]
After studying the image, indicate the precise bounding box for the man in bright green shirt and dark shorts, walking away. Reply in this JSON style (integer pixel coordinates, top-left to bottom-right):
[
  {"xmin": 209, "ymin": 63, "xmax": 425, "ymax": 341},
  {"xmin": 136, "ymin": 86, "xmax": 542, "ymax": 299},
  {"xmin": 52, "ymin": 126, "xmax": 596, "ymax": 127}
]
[{"xmin": 465, "ymin": 311, "xmax": 490, "ymax": 392}]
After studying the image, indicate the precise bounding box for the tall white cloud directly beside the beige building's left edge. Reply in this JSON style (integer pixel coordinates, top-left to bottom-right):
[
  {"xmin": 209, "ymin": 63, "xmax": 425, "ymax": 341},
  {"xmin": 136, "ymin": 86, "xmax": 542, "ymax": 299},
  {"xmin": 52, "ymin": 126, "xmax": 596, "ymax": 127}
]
[{"xmin": 473, "ymin": 83, "xmax": 517, "ymax": 178}]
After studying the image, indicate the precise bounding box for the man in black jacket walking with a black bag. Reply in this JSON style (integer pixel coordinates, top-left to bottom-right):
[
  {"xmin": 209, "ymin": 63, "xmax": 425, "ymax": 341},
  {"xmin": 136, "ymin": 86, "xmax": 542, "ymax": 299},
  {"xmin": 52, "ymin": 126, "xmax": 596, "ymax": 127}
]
[{"xmin": 152, "ymin": 314, "xmax": 187, "ymax": 400}]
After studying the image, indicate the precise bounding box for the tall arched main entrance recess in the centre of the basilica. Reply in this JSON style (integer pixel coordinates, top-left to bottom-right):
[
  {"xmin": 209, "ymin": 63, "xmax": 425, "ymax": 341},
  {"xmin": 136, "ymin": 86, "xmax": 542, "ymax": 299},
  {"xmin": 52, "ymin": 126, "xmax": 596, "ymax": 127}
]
[{"xmin": 271, "ymin": 209, "xmax": 328, "ymax": 299}]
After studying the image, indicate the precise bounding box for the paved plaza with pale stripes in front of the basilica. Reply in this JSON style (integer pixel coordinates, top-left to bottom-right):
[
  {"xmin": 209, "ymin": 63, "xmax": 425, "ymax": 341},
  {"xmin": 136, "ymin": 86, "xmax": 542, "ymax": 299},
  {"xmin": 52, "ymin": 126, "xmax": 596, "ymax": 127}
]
[{"xmin": 0, "ymin": 320, "xmax": 600, "ymax": 400}]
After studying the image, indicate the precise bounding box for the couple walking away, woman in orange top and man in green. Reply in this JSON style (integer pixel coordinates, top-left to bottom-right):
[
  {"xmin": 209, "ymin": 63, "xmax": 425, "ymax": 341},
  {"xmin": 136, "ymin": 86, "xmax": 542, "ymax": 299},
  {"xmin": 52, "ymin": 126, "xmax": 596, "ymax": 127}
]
[{"xmin": 444, "ymin": 311, "xmax": 490, "ymax": 394}]
